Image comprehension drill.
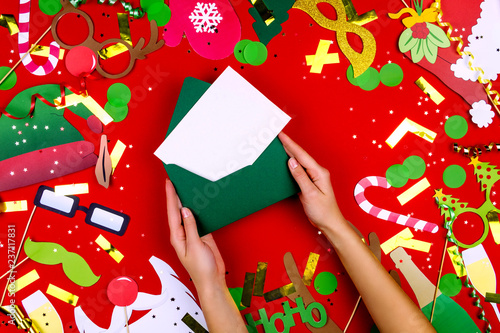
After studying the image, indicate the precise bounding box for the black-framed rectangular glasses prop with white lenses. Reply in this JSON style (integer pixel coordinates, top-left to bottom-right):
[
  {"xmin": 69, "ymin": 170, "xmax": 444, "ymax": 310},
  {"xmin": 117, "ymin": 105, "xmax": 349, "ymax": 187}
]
[{"xmin": 34, "ymin": 185, "xmax": 130, "ymax": 236}]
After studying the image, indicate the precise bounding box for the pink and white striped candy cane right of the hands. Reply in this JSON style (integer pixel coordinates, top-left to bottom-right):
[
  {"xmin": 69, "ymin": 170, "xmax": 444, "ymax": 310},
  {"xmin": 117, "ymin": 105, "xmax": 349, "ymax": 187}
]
[{"xmin": 354, "ymin": 176, "xmax": 439, "ymax": 233}]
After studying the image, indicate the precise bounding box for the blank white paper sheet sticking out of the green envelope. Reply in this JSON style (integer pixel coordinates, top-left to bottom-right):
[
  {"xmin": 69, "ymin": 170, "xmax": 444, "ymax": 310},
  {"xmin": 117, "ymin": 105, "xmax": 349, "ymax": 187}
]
[{"xmin": 155, "ymin": 67, "xmax": 290, "ymax": 181}]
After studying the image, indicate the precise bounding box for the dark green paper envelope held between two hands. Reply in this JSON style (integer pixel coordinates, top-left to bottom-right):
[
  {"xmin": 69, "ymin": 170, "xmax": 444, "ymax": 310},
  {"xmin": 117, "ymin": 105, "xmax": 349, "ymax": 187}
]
[{"xmin": 165, "ymin": 77, "xmax": 299, "ymax": 236}]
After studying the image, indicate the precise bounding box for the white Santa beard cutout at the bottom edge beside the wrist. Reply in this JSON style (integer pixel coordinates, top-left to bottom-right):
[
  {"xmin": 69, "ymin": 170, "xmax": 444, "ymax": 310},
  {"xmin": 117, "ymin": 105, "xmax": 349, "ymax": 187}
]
[{"xmin": 75, "ymin": 256, "xmax": 207, "ymax": 333}]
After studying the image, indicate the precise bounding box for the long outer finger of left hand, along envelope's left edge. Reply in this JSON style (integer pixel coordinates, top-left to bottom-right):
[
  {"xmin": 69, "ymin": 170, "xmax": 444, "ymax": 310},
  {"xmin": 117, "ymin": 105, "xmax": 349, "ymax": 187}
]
[{"xmin": 165, "ymin": 179, "xmax": 186, "ymax": 252}]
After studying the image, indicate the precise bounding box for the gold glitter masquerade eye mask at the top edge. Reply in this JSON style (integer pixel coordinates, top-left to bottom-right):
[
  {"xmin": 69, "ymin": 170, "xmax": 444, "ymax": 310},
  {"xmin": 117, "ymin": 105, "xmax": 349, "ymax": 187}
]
[{"xmin": 292, "ymin": 0, "xmax": 377, "ymax": 77}]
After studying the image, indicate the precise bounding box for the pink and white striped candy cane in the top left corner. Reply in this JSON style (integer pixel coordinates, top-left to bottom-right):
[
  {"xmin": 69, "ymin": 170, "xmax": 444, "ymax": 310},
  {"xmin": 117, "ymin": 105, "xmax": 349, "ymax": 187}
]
[{"xmin": 17, "ymin": 0, "xmax": 60, "ymax": 75}]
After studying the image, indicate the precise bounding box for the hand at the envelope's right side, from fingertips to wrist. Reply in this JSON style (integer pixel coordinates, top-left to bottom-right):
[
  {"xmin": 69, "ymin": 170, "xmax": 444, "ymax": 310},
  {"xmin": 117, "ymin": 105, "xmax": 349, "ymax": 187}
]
[{"xmin": 278, "ymin": 132, "xmax": 345, "ymax": 231}]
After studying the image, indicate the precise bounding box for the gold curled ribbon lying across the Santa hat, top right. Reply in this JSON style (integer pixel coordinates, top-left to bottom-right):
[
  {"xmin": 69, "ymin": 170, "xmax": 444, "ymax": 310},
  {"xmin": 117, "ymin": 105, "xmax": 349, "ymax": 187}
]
[{"xmin": 431, "ymin": 0, "xmax": 500, "ymax": 114}]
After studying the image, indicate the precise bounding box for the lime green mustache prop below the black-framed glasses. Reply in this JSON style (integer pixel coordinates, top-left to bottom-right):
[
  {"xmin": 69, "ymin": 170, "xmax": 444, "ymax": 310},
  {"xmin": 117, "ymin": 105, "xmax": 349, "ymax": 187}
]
[{"xmin": 24, "ymin": 237, "xmax": 101, "ymax": 287}]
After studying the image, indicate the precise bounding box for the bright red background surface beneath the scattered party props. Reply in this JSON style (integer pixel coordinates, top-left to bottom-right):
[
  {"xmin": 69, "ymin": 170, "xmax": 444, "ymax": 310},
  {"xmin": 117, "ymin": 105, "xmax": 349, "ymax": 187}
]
[{"xmin": 0, "ymin": 0, "xmax": 500, "ymax": 332}]
